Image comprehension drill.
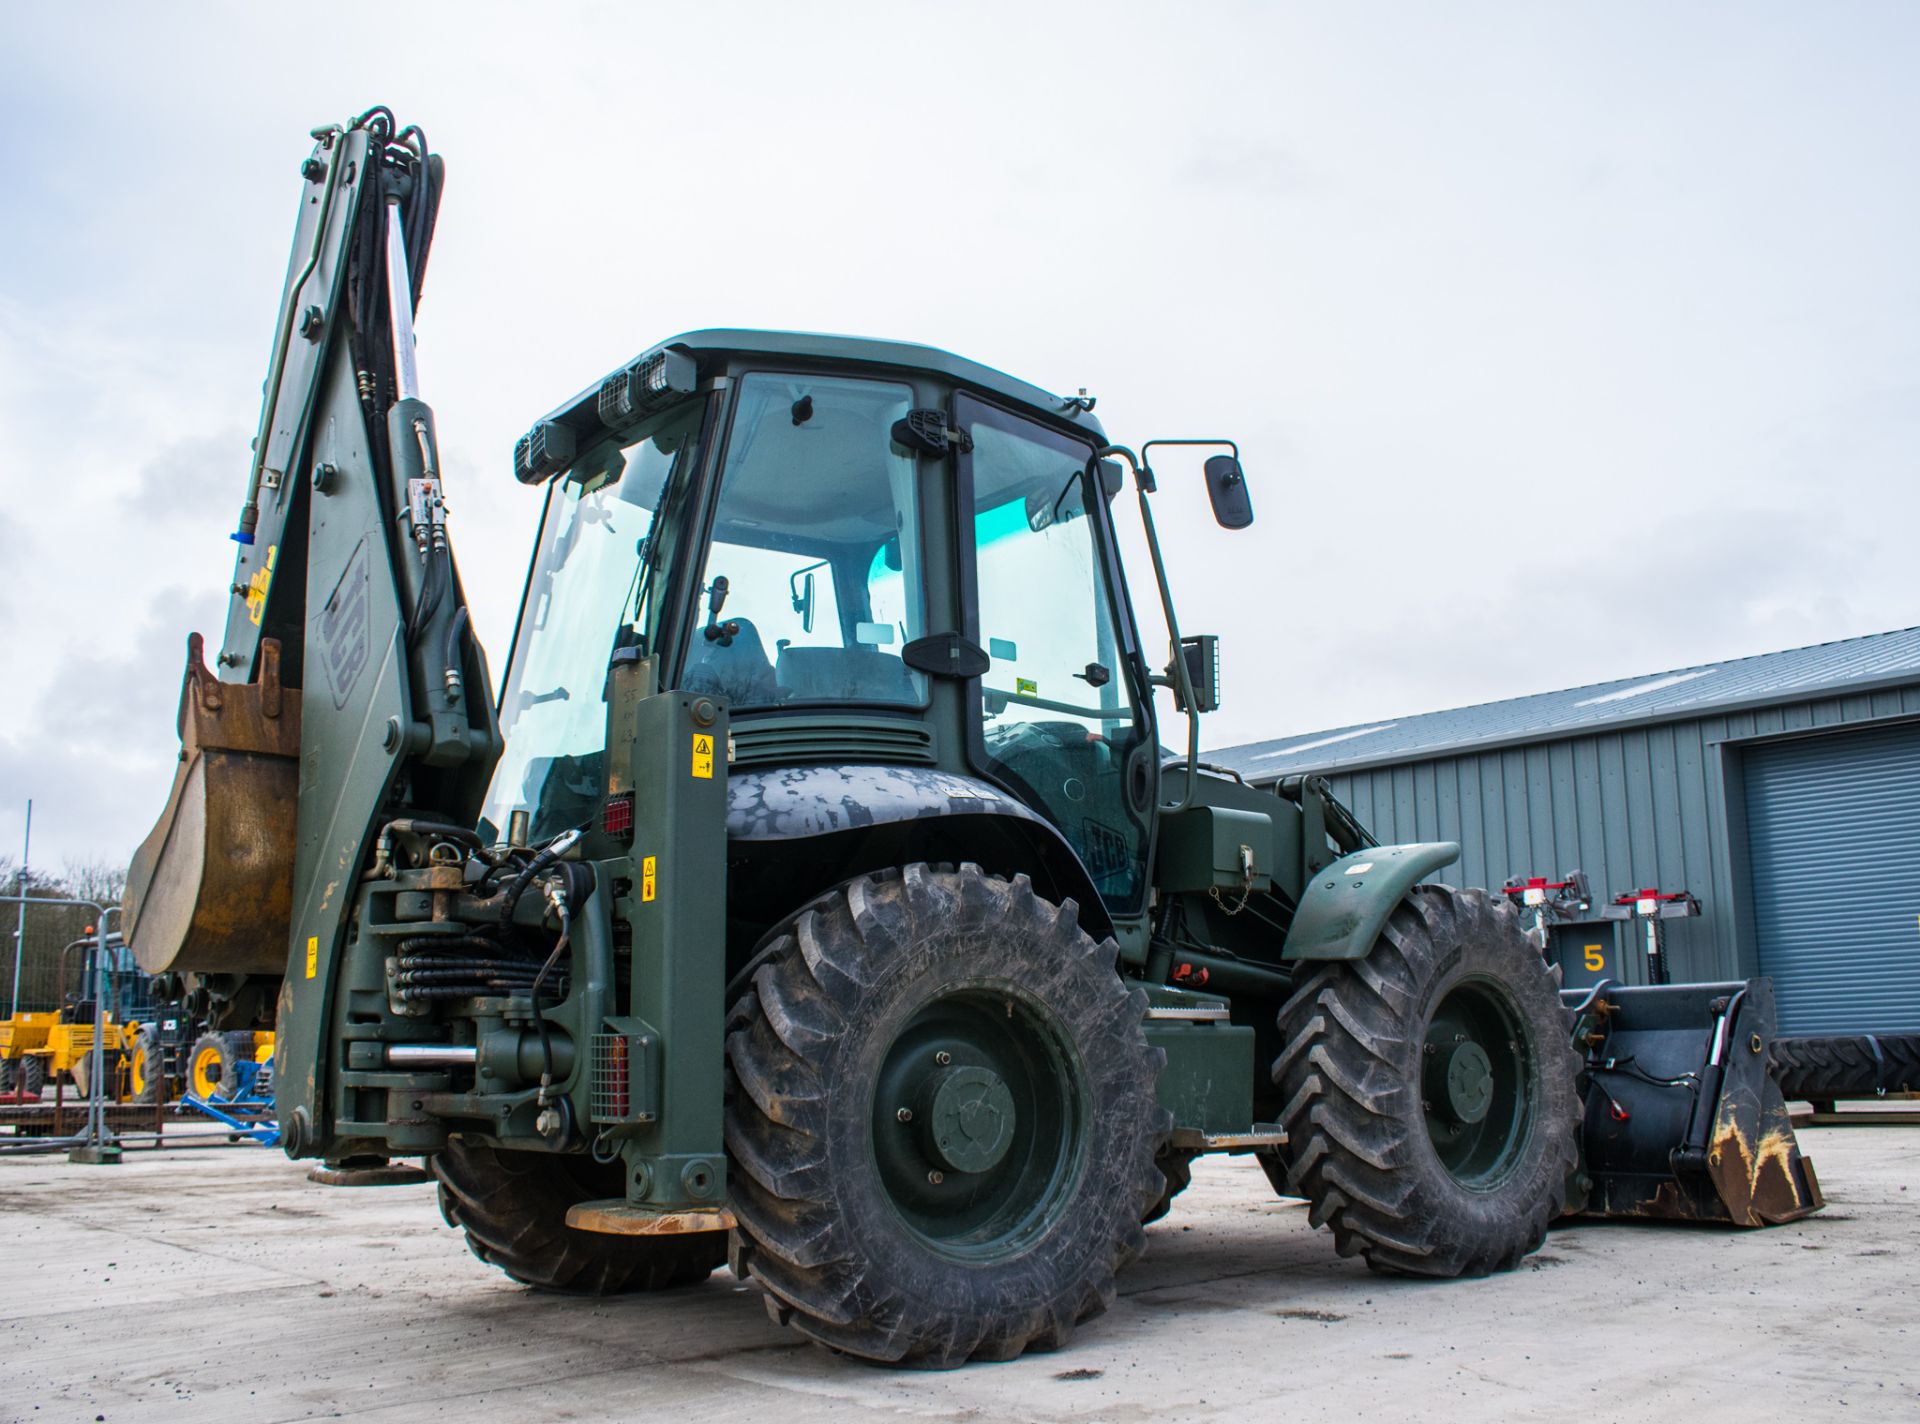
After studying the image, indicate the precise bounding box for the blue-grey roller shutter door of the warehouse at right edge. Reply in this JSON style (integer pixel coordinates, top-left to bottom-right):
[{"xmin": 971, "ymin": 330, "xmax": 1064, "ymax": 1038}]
[{"xmin": 1745, "ymin": 725, "xmax": 1920, "ymax": 1034}]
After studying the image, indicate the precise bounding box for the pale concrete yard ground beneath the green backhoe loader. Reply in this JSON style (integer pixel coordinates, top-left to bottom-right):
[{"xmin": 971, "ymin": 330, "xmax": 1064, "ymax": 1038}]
[{"xmin": 0, "ymin": 1127, "xmax": 1920, "ymax": 1424}]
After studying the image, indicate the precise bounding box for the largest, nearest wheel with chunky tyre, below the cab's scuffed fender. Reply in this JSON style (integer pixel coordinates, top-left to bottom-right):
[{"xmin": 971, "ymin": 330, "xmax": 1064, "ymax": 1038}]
[{"xmin": 726, "ymin": 866, "xmax": 1171, "ymax": 1368}]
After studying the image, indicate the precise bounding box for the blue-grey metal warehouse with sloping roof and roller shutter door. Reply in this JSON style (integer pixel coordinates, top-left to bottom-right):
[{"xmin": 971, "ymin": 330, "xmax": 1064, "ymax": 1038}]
[{"xmin": 1210, "ymin": 628, "xmax": 1920, "ymax": 1034}]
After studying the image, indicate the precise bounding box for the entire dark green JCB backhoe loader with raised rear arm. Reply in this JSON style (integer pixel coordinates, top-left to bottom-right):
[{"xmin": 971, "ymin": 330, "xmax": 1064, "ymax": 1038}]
[{"xmin": 129, "ymin": 107, "xmax": 1818, "ymax": 1366}]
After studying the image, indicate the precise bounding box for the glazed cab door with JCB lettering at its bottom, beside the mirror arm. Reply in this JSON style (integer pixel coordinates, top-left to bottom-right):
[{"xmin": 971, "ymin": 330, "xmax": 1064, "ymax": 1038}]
[{"xmin": 954, "ymin": 395, "xmax": 1158, "ymax": 915}]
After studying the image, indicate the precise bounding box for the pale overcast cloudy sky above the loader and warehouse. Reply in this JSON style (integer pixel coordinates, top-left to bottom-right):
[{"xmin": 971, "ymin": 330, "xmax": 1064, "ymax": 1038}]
[{"xmin": 0, "ymin": 0, "xmax": 1920, "ymax": 864}]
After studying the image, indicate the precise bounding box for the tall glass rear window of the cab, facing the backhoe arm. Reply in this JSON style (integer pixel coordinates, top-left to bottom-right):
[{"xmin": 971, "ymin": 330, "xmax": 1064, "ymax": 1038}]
[{"xmin": 480, "ymin": 401, "xmax": 705, "ymax": 841}]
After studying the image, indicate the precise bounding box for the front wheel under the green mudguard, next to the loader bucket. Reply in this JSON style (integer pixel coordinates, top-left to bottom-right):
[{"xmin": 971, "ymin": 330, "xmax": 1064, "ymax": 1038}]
[{"xmin": 1273, "ymin": 887, "xmax": 1580, "ymax": 1276}]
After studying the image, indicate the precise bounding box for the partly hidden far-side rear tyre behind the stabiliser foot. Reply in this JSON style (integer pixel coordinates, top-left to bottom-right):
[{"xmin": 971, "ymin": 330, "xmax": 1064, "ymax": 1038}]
[{"xmin": 428, "ymin": 1138, "xmax": 726, "ymax": 1295}]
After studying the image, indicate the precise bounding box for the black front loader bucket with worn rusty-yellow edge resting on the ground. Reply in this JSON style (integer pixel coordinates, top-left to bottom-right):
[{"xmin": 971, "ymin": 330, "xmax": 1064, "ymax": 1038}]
[{"xmin": 1563, "ymin": 979, "xmax": 1826, "ymax": 1226}]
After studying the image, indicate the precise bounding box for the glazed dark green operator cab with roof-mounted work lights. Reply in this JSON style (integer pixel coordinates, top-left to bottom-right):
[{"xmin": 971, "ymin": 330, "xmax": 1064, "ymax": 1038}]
[{"xmin": 482, "ymin": 332, "xmax": 1158, "ymax": 914}]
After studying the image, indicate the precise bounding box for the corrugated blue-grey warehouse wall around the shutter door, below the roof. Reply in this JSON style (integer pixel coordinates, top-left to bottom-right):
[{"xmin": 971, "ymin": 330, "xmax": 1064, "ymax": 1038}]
[{"xmin": 1327, "ymin": 685, "xmax": 1920, "ymax": 979}]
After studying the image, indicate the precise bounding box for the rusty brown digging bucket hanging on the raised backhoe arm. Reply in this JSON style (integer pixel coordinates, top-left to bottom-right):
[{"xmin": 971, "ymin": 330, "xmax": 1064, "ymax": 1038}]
[{"xmin": 125, "ymin": 633, "xmax": 300, "ymax": 975}]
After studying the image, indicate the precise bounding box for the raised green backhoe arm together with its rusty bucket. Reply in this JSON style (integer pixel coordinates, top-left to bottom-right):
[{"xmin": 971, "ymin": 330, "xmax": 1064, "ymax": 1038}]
[{"xmin": 127, "ymin": 109, "xmax": 501, "ymax": 1151}]
